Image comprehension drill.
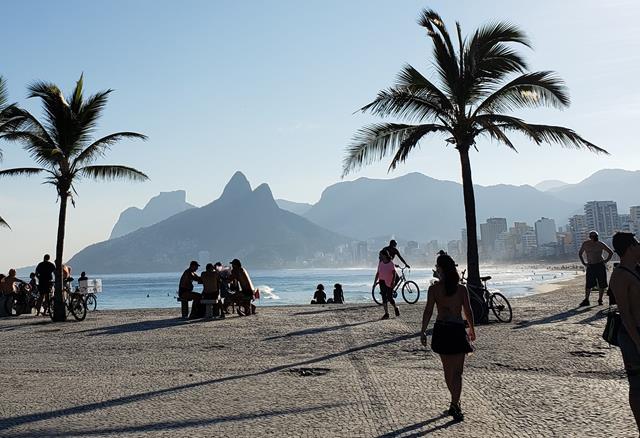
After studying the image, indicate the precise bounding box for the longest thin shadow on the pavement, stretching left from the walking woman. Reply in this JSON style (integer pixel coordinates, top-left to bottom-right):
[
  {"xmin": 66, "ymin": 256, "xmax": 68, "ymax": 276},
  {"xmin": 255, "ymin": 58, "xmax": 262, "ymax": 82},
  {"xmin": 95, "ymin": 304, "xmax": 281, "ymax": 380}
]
[{"xmin": 0, "ymin": 332, "xmax": 420, "ymax": 436}]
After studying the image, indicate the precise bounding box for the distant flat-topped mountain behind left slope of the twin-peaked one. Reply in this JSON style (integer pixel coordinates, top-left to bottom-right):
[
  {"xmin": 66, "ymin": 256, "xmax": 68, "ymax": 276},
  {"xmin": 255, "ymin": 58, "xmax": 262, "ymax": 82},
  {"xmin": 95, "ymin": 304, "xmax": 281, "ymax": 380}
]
[{"xmin": 109, "ymin": 190, "xmax": 195, "ymax": 239}]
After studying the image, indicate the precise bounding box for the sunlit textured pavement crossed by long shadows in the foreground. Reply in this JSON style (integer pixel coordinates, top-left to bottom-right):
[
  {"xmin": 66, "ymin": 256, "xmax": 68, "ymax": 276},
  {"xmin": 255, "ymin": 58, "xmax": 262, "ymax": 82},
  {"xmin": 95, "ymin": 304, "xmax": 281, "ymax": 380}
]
[{"xmin": 0, "ymin": 279, "xmax": 637, "ymax": 437}]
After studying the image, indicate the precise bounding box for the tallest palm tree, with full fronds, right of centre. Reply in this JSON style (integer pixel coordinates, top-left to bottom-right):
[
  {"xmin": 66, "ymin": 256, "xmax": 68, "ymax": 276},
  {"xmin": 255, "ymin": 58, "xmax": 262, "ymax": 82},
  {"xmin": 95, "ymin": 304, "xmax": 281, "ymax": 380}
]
[{"xmin": 343, "ymin": 9, "xmax": 607, "ymax": 285}]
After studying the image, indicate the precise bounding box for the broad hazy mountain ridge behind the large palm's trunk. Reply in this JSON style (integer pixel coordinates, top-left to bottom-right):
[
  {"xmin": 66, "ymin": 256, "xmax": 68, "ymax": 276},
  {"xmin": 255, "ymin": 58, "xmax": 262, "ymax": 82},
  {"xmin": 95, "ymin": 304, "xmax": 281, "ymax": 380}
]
[{"xmin": 304, "ymin": 173, "xmax": 581, "ymax": 241}]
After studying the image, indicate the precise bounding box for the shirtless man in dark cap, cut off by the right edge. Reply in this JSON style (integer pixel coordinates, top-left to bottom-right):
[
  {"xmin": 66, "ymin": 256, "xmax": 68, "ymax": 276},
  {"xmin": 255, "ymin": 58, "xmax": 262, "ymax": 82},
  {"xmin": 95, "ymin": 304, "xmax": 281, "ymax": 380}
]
[{"xmin": 611, "ymin": 233, "xmax": 640, "ymax": 431}]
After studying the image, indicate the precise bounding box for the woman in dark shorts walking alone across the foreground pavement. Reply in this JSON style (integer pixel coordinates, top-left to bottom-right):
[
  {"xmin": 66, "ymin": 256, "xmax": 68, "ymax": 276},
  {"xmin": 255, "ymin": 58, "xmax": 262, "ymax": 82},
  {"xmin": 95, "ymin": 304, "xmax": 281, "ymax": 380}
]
[{"xmin": 420, "ymin": 254, "xmax": 476, "ymax": 421}]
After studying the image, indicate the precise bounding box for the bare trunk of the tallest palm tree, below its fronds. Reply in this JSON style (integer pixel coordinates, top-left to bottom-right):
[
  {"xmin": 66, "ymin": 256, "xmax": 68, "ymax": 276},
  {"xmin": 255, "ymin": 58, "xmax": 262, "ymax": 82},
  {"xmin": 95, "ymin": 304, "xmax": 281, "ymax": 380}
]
[{"xmin": 458, "ymin": 146, "xmax": 480, "ymax": 286}]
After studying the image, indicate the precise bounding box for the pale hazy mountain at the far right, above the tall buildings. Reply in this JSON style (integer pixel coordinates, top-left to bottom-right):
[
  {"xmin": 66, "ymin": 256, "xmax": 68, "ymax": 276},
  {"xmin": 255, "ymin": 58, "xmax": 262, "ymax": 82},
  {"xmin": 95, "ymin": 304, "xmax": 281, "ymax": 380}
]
[{"xmin": 550, "ymin": 169, "xmax": 640, "ymax": 213}]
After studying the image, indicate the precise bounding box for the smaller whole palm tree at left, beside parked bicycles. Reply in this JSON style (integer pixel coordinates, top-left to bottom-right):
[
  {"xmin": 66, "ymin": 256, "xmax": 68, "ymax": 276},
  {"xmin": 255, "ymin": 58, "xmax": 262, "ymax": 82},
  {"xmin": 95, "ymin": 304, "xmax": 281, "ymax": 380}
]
[{"xmin": 0, "ymin": 76, "xmax": 148, "ymax": 321}]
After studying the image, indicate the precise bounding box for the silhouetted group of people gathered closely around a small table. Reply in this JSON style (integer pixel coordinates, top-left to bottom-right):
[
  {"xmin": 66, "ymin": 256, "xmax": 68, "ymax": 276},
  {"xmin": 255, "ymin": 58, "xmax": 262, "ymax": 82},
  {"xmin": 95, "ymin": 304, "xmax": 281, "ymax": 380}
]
[{"xmin": 178, "ymin": 259, "xmax": 260, "ymax": 319}]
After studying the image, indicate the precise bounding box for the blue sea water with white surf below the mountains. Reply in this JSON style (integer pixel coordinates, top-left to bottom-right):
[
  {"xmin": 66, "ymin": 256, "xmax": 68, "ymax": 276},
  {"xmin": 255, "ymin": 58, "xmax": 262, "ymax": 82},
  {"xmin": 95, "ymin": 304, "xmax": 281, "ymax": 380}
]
[{"xmin": 81, "ymin": 266, "xmax": 578, "ymax": 310}]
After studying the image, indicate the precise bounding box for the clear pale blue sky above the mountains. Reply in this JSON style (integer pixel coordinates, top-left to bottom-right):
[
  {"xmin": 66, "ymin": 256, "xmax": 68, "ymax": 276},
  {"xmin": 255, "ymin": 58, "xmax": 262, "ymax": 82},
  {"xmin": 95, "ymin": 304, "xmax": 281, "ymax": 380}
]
[{"xmin": 0, "ymin": 0, "xmax": 640, "ymax": 272}]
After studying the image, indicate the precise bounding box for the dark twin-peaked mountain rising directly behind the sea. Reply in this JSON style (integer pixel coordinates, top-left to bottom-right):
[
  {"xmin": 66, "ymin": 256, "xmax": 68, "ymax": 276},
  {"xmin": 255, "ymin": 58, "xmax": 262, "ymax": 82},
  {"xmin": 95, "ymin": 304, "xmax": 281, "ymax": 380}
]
[{"xmin": 69, "ymin": 172, "xmax": 349, "ymax": 273}]
